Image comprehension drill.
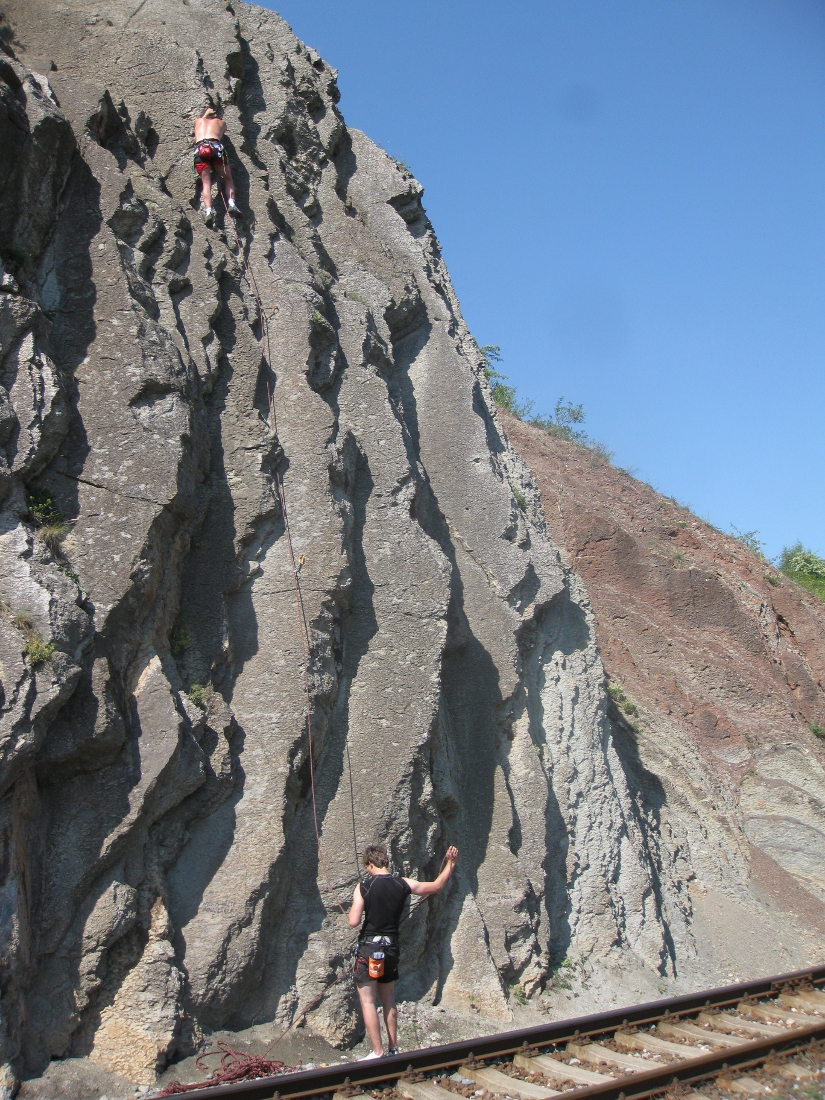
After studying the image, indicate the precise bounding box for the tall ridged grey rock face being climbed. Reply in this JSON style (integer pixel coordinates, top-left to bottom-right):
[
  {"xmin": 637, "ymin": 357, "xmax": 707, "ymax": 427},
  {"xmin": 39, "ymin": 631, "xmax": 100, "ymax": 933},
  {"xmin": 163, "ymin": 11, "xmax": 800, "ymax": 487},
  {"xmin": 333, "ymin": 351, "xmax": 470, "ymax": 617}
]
[{"xmin": 0, "ymin": 0, "xmax": 692, "ymax": 1084}]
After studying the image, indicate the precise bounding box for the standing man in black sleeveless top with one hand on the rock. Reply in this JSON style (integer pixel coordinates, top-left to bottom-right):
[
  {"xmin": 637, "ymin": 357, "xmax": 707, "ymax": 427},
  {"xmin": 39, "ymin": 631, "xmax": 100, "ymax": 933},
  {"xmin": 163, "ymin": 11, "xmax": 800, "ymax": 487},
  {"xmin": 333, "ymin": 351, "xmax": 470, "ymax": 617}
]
[{"xmin": 347, "ymin": 844, "xmax": 459, "ymax": 1060}]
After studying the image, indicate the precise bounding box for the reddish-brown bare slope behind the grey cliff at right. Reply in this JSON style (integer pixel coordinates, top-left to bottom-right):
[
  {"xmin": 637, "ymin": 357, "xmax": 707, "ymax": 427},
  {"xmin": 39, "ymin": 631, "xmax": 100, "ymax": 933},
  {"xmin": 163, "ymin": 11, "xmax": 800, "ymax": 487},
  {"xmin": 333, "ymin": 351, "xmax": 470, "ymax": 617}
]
[{"xmin": 502, "ymin": 414, "xmax": 825, "ymax": 925}]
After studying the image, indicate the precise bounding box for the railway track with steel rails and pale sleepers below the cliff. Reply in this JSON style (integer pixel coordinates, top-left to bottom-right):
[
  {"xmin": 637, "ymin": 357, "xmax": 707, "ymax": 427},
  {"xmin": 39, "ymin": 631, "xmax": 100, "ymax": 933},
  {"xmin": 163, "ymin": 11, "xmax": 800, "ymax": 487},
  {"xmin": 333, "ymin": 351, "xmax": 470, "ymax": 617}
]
[{"xmin": 159, "ymin": 967, "xmax": 825, "ymax": 1100}]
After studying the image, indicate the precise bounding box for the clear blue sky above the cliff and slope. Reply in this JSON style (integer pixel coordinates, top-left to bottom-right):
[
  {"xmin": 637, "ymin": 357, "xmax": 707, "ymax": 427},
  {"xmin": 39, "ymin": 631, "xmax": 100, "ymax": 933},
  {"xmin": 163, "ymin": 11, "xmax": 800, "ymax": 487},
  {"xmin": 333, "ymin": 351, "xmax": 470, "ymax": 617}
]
[{"xmin": 261, "ymin": 0, "xmax": 825, "ymax": 556}]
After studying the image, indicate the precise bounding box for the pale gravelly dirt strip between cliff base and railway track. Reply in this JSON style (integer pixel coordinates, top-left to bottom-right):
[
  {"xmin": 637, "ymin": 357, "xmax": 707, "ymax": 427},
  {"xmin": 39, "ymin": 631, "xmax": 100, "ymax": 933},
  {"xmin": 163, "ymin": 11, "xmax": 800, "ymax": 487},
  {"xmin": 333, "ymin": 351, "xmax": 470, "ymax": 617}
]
[{"xmin": 19, "ymin": 881, "xmax": 825, "ymax": 1100}]
